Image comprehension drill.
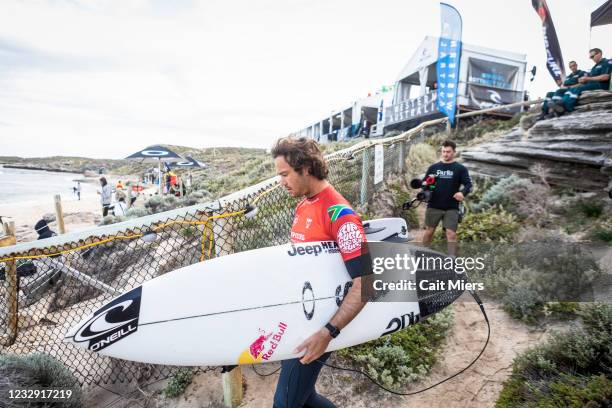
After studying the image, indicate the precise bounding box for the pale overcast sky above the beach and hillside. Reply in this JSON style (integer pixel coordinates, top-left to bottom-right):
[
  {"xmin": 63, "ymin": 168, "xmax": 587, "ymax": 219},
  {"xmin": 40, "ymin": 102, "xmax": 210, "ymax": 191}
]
[{"xmin": 0, "ymin": 0, "xmax": 612, "ymax": 158}]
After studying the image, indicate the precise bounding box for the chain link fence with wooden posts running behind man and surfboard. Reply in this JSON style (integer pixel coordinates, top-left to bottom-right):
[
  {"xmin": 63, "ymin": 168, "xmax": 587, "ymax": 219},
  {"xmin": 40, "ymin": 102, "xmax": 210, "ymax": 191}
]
[{"xmin": 0, "ymin": 127, "xmax": 440, "ymax": 384}]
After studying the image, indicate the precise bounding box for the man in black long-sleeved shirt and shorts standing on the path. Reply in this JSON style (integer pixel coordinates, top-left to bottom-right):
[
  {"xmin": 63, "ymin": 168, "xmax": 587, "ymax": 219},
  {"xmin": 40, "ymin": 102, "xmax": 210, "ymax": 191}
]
[{"xmin": 423, "ymin": 140, "xmax": 472, "ymax": 249}]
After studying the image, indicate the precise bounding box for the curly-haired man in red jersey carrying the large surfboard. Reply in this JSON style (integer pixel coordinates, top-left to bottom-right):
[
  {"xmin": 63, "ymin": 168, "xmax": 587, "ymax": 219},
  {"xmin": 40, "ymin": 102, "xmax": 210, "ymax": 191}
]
[{"xmin": 272, "ymin": 137, "xmax": 366, "ymax": 408}]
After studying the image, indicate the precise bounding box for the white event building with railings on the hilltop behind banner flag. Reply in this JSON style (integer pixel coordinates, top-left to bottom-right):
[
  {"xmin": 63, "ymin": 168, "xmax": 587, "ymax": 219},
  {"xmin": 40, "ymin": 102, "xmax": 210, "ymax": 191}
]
[{"xmin": 295, "ymin": 36, "xmax": 527, "ymax": 143}]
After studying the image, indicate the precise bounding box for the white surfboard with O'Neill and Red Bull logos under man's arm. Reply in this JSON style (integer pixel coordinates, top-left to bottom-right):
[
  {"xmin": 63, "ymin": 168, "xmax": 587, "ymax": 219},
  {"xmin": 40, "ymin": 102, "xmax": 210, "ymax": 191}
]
[{"xmin": 65, "ymin": 223, "xmax": 461, "ymax": 366}]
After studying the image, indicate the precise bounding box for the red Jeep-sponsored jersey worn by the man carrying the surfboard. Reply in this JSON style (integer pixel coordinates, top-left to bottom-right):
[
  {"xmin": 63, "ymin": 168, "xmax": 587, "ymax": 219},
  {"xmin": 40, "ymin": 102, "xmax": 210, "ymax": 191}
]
[{"xmin": 291, "ymin": 185, "xmax": 366, "ymax": 268}]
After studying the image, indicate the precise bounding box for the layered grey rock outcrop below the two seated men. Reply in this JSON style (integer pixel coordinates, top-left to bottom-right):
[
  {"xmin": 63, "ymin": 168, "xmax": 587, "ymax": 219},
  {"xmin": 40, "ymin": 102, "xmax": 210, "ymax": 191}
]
[{"xmin": 461, "ymin": 91, "xmax": 612, "ymax": 190}]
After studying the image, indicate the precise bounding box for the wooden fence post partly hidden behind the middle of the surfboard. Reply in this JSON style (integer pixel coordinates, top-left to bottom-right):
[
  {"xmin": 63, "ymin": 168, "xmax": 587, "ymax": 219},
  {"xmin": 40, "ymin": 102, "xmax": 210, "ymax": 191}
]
[{"xmin": 213, "ymin": 217, "xmax": 243, "ymax": 408}]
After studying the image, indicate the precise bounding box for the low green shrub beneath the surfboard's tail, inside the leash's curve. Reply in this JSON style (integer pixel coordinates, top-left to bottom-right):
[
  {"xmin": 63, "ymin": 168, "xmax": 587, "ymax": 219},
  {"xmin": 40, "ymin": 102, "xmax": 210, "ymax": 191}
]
[{"xmin": 337, "ymin": 309, "xmax": 453, "ymax": 388}]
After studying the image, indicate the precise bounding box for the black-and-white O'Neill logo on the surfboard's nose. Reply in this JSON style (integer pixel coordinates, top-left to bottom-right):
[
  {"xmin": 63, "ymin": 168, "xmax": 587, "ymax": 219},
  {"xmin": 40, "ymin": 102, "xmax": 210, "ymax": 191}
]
[{"xmin": 74, "ymin": 287, "xmax": 142, "ymax": 351}]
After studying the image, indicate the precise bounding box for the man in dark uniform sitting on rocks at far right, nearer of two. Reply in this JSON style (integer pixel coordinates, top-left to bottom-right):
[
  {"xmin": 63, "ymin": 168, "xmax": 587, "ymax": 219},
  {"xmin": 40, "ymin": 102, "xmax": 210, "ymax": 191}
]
[{"xmin": 553, "ymin": 48, "xmax": 612, "ymax": 115}]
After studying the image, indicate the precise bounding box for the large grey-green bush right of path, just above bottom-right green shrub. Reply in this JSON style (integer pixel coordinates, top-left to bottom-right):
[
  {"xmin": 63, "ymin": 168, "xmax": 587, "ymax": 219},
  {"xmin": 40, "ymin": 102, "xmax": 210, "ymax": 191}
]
[{"xmin": 471, "ymin": 235, "xmax": 602, "ymax": 324}]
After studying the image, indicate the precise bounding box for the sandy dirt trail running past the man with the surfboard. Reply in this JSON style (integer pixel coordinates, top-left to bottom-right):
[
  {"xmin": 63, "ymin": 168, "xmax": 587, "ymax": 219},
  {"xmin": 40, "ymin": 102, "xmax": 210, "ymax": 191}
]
[{"xmin": 164, "ymin": 295, "xmax": 545, "ymax": 408}]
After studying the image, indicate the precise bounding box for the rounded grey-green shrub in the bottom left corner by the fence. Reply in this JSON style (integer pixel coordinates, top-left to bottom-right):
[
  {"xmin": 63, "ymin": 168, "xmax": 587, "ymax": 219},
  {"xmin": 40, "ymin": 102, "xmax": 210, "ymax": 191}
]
[{"xmin": 0, "ymin": 354, "xmax": 84, "ymax": 408}]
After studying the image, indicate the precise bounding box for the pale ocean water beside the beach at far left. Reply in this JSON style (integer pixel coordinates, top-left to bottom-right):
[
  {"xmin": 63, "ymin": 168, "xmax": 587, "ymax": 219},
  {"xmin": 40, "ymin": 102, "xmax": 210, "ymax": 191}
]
[{"xmin": 0, "ymin": 166, "xmax": 97, "ymax": 204}]
